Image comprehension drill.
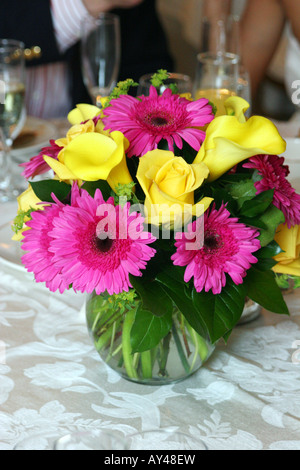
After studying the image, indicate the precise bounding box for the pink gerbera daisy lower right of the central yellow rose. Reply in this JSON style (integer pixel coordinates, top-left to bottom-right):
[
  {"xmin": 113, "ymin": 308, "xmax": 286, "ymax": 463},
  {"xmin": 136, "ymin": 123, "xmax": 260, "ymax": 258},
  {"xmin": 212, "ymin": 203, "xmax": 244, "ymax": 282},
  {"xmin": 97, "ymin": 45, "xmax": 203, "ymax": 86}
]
[{"xmin": 172, "ymin": 205, "xmax": 260, "ymax": 294}]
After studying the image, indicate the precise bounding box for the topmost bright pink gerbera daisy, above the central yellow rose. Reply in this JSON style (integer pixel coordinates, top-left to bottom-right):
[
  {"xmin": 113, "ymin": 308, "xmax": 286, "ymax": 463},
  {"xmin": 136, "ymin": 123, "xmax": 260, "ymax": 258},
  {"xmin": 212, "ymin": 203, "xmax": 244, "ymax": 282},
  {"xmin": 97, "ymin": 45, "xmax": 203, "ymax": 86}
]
[{"xmin": 103, "ymin": 86, "xmax": 214, "ymax": 157}]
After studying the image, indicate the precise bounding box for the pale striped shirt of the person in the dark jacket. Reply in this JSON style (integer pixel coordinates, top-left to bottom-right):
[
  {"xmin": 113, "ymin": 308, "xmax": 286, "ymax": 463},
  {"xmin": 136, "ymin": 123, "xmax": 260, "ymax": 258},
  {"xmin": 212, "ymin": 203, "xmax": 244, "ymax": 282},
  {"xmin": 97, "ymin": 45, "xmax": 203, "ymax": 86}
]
[{"xmin": 26, "ymin": 0, "xmax": 89, "ymax": 119}]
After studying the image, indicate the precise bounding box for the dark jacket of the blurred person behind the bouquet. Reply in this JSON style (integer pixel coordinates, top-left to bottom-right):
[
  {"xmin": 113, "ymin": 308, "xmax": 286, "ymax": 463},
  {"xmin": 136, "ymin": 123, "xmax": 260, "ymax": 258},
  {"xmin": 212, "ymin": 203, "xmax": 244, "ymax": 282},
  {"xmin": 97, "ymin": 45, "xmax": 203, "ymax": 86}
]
[{"xmin": 0, "ymin": 0, "xmax": 173, "ymax": 105}]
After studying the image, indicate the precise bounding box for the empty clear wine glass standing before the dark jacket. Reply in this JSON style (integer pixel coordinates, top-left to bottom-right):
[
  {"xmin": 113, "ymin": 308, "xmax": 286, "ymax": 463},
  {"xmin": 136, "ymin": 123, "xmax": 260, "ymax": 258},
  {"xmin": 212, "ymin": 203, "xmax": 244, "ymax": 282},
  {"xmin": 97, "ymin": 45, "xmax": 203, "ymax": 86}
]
[{"xmin": 81, "ymin": 13, "xmax": 121, "ymax": 107}]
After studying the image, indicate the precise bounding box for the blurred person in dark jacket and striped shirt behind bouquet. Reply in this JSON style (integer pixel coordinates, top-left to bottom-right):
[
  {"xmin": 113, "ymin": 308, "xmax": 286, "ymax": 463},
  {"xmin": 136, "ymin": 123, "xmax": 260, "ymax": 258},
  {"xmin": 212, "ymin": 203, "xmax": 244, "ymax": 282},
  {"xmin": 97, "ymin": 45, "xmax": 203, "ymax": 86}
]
[{"xmin": 0, "ymin": 0, "xmax": 173, "ymax": 119}]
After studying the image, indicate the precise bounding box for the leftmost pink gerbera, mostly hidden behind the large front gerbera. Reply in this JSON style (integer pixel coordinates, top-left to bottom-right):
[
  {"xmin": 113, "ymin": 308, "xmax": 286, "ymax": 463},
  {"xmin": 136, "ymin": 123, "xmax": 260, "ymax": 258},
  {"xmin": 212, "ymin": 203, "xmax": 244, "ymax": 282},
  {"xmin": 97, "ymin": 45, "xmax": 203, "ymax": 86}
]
[{"xmin": 22, "ymin": 204, "xmax": 69, "ymax": 293}]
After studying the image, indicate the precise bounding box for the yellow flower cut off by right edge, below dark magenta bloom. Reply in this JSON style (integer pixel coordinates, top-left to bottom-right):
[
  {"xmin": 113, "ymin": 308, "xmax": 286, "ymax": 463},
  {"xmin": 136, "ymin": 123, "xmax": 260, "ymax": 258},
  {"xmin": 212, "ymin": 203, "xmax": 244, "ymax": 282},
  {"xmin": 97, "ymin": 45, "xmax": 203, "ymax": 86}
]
[{"xmin": 273, "ymin": 225, "xmax": 300, "ymax": 276}]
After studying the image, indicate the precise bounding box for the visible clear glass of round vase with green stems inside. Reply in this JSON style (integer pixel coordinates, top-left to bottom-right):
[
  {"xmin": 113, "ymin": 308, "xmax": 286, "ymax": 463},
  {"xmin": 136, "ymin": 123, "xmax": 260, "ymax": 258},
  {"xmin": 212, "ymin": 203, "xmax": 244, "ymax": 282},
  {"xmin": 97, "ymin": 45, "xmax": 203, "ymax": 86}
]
[{"xmin": 86, "ymin": 293, "xmax": 215, "ymax": 385}]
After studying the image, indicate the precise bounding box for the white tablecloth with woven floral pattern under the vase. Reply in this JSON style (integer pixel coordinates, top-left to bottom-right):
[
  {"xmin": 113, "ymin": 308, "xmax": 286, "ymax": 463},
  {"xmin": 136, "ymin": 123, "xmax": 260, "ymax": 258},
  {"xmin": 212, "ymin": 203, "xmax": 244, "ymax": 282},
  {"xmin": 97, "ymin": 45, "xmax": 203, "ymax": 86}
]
[{"xmin": 0, "ymin": 197, "xmax": 300, "ymax": 450}]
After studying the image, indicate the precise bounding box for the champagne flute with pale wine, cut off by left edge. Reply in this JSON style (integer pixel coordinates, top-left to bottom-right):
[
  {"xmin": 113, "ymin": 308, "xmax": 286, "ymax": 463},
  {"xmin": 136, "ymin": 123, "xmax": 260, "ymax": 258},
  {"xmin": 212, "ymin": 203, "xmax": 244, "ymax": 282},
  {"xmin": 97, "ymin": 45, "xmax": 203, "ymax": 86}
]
[{"xmin": 0, "ymin": 39, "xmax": 26, "ymax": 202}]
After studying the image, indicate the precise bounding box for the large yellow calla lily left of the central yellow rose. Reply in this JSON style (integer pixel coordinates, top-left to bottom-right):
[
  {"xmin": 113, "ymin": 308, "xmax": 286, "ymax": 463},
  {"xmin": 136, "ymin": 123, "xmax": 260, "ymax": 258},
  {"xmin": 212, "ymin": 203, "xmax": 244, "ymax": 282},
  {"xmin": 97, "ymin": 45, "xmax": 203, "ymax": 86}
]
[{"xmin": 64, "ymin": 131, "xmax": 132, "ymax": 190}]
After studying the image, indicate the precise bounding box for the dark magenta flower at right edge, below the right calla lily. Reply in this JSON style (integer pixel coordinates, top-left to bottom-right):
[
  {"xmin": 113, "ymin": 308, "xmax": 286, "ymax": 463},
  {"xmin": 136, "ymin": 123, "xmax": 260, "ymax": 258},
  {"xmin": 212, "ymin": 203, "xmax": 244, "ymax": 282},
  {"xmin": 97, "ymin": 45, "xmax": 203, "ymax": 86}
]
[{"xmin": 243, "ymin": 155, "xmax": 300, "ymax": 228}]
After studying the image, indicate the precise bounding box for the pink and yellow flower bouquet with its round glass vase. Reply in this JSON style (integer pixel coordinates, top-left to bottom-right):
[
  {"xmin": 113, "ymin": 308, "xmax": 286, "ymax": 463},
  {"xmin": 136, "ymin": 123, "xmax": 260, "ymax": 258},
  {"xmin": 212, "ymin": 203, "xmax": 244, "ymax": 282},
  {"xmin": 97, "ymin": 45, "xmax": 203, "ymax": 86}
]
[{"xmin": 14, "ymin": 70, "xmax": 300, "ymax": 383}]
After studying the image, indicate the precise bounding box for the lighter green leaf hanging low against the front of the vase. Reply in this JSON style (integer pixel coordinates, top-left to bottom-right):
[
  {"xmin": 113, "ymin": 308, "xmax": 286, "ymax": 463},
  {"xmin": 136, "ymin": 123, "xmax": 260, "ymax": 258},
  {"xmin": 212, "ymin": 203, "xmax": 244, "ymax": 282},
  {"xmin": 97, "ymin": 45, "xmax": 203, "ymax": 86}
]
[{"xmin": 130, "ymin": 307, "xmax": 172, "ymax": 354}]
